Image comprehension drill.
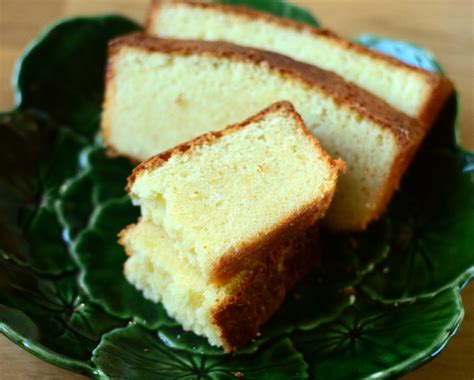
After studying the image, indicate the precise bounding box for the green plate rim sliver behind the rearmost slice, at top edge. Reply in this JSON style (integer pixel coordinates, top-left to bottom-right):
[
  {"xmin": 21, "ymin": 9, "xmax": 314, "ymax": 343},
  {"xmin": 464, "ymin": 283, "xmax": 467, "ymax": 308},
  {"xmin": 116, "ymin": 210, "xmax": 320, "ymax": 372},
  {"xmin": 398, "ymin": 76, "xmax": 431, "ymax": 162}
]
[{"xmin": 212, "ymin": 0, "xmax": 319, "ymax": 27}]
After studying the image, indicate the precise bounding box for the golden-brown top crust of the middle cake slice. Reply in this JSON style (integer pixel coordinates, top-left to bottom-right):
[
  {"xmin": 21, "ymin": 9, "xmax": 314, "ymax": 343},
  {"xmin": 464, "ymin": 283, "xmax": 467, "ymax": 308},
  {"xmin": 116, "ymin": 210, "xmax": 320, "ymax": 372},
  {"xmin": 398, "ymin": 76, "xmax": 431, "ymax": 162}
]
[{"xmin": 109, "ymin": 33, "xmax": 425, "ymax": 150}]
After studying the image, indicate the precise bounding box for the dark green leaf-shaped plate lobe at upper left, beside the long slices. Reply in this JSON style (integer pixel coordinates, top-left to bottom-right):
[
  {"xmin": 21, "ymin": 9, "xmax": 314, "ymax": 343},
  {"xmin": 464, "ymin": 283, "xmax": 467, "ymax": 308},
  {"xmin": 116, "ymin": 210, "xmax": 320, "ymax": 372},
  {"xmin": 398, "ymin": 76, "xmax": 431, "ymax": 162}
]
[{"xmin": 15, "ymin": 15, "xmax": 140, "ymax": 138}]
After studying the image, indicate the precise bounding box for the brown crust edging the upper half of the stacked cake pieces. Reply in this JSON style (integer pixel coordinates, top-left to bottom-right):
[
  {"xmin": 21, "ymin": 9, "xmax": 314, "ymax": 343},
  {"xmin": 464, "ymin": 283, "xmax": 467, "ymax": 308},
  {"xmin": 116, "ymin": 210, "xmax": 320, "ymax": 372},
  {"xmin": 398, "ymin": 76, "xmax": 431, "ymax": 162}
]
[{"xmin": 127, "ymin": 101, "xmax": 345, "ymax": 285}]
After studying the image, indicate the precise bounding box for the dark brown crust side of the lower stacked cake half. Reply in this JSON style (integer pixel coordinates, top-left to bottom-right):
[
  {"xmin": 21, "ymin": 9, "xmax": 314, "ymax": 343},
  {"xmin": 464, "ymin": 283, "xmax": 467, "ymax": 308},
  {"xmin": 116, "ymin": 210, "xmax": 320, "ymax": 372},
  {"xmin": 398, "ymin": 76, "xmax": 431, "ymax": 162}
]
[{"xmin": 212, "ymin": 226, "xmax": 320, "ymax": 352}]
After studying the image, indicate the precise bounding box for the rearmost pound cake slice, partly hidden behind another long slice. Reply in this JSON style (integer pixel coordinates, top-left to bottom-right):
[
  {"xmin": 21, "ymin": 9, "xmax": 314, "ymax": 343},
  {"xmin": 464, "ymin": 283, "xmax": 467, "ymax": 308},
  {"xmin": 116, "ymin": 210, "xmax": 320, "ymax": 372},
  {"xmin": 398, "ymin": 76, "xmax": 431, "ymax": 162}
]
[{"xmin": 147, "ymin": 0, "xmax": 452, "ymax": 125}]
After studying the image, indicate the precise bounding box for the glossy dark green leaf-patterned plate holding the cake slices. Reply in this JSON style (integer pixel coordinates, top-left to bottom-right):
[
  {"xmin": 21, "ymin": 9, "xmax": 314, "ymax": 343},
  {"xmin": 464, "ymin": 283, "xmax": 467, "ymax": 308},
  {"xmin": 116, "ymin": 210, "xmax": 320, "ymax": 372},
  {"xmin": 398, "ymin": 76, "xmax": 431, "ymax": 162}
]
[{"xmin": 0, "ymin": 0, "xmax": 474, "ymax": 379}]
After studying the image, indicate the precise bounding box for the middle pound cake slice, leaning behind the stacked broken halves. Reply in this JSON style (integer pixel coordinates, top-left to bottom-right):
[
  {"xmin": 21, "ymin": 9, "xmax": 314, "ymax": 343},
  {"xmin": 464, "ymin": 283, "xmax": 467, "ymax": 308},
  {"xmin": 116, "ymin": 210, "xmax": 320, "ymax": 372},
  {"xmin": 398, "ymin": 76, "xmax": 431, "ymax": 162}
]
[{"xmin": 102, "ymin": 34, "xmax": 426, "ymax": 231}]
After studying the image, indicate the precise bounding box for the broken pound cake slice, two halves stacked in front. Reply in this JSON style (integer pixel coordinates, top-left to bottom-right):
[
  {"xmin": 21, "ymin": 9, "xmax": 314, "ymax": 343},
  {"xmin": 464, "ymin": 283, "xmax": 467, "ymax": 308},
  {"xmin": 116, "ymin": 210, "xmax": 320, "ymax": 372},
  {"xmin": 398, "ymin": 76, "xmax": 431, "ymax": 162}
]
[{"xmin": 119, "ymin": 102, "xmax": 343, "ymax": 351}]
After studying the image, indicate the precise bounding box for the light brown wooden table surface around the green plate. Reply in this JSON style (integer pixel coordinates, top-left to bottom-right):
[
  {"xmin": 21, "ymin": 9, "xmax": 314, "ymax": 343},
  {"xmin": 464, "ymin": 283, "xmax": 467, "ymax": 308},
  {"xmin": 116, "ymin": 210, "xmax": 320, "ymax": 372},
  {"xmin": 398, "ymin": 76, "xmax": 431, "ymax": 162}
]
[{"xmin": 0, "ymin": 0, "xmax": 474, "ymax": 380}]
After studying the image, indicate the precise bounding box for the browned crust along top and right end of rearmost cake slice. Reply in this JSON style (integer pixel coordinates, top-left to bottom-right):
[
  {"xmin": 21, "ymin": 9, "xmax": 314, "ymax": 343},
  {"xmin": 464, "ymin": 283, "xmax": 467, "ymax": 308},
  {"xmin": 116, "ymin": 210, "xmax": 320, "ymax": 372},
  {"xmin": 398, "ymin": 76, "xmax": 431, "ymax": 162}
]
[{"xmin": 150, "ymin": 0, "xmax": 454, "ymax": 126}]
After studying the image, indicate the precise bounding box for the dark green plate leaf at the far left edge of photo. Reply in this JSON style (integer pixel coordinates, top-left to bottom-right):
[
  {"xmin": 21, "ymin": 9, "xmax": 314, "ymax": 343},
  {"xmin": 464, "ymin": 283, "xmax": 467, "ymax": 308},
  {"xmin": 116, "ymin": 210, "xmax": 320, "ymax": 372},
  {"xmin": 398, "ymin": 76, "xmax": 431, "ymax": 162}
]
[{"xmin": 0, "ymin": 112, "xmax": 85, "ymax": 274}]
